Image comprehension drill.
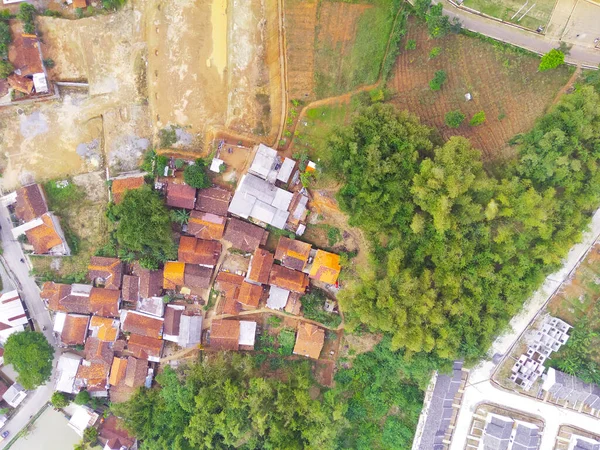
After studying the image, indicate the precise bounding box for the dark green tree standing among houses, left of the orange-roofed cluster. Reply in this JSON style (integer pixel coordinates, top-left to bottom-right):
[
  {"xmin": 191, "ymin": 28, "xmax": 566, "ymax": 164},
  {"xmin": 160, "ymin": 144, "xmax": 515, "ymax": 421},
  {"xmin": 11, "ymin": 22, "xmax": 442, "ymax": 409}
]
[{"xmin": 112, "ymin": 186, "xmax": 175, "ymax": 269}]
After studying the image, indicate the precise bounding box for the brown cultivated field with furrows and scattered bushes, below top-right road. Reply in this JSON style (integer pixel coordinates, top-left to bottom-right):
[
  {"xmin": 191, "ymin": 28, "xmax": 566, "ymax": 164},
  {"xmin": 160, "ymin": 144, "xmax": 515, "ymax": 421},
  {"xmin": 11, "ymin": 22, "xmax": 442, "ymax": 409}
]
[{"xmin": 388, "ymin": 20, "xmax": 572, "ymax": 159}]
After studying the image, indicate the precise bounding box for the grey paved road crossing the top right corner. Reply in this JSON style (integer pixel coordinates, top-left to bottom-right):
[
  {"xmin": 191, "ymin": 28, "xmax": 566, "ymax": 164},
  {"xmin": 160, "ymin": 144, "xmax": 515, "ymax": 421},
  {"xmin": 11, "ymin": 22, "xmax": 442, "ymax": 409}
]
[{"xmin": 434, "ymin": 0, "xmax": 600, "ymax": 67}]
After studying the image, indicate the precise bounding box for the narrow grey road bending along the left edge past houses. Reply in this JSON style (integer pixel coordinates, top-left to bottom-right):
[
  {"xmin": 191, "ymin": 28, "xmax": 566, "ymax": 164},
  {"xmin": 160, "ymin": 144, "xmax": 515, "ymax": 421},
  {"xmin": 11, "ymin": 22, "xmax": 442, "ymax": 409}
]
[{"xmin": 0, "ymin": 204, "xmax": 59, "ymax": 449}]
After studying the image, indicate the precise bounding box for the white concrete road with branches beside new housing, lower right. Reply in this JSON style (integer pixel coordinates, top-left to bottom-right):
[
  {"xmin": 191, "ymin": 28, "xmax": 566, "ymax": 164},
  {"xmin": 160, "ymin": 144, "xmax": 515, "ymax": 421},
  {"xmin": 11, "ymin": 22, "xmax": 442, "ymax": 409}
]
[{"xmin": 450, "ymin": 210, "xmax": 600, "ymax": 450}]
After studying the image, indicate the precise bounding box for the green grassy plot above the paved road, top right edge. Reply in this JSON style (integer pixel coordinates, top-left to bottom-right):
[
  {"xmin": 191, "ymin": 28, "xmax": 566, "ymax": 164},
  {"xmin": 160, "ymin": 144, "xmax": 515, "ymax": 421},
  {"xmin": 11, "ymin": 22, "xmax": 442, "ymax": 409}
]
[{"xmin": 463, "ymin": 0, "xmax": 556, "ymax": 30}]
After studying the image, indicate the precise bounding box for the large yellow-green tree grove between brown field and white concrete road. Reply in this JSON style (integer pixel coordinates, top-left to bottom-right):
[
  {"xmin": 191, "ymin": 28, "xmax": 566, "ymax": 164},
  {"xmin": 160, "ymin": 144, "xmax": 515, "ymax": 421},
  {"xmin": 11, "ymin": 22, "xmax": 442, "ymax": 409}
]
[{"xmin": 324, "ymin": 86, "xmax": 600, "ymax": 358}]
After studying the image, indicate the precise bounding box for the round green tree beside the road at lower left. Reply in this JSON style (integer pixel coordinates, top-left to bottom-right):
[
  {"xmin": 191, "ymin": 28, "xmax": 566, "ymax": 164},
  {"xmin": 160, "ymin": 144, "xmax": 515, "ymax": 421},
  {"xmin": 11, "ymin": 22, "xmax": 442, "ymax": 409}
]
[{"xmin": 4, "ymin": 331, "xmax": 54, "ymax": 390}]
